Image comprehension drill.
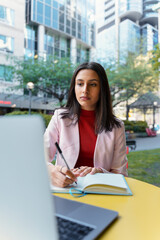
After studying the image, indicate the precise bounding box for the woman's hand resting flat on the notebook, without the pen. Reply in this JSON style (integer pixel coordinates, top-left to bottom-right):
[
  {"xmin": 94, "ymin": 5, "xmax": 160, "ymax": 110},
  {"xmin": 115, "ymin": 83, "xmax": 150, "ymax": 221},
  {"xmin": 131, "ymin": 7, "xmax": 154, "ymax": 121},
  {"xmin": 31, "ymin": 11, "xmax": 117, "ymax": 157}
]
[{"xmin": 72, "ymin": 166, "xmax": 103, "ymax": 177}]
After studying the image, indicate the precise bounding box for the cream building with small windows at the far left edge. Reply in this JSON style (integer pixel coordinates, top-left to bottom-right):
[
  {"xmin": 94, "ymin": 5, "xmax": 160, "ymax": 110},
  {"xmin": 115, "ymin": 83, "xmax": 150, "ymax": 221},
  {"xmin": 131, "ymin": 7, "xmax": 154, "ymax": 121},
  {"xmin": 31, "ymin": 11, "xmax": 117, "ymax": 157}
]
[{"xmin": 0, "ymin": 0, "xmax": 25, "ymax": 93}]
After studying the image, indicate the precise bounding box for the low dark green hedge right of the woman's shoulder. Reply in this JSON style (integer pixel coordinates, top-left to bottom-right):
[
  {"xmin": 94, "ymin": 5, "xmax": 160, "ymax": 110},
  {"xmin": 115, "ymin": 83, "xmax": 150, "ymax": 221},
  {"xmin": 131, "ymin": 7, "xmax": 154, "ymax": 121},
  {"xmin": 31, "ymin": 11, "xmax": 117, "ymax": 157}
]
[{"xmin": 124, "ymin": 120, "xmax": 148, "ymax": 132}]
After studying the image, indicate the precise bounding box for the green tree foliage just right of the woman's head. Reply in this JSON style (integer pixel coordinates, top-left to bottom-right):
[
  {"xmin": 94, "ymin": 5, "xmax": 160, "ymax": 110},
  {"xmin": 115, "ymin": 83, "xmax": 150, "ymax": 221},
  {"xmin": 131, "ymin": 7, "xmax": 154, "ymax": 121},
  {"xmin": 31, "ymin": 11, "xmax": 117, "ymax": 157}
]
[{"xmin": 106, "ymin": 55, "xmax": 157, "ymax": 106}]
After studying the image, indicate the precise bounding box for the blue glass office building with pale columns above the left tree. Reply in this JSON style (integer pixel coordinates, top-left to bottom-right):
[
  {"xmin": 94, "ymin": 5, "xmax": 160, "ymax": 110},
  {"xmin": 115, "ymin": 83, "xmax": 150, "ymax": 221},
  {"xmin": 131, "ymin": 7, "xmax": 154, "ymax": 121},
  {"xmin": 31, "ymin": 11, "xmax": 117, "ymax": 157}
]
[{"xmin": 25, "ymin": 0, "xmax": 95, "ymax": 62}]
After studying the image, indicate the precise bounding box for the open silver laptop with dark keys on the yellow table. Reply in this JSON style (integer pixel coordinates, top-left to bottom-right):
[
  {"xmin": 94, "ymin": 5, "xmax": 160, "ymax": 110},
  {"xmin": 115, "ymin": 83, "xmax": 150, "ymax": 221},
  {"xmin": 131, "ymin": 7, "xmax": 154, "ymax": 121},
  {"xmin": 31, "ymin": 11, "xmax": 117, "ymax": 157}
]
[{"xmin": 0, "ymin": 115, "xmax": 118, "ymax": 240}]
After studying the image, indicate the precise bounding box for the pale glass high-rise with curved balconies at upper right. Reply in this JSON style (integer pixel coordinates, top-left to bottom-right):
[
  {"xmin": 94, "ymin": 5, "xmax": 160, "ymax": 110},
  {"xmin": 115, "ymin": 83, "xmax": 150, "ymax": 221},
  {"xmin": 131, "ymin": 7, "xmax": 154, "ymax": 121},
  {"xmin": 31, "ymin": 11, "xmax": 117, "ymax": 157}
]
[{"xmin": 97, "ymin": 0, "xmax": 158, "ymax": 61}]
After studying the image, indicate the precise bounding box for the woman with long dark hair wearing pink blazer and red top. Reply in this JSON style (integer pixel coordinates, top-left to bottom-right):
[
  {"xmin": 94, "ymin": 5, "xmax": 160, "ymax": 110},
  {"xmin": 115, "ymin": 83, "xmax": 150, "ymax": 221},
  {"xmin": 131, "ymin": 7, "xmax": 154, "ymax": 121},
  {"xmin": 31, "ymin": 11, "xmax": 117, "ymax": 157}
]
[{"xmin": 44, "ymin": 62, "xmax": 127, "ymax": 187}]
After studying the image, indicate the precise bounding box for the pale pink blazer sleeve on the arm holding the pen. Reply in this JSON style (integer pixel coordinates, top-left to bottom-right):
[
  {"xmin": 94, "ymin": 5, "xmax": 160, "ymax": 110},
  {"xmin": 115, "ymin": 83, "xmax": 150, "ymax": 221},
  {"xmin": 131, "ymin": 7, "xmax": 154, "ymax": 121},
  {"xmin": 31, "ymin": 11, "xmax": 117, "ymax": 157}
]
[{"xmin": 44, "ymin": 111, "xmax": 59, "ymax": 162}]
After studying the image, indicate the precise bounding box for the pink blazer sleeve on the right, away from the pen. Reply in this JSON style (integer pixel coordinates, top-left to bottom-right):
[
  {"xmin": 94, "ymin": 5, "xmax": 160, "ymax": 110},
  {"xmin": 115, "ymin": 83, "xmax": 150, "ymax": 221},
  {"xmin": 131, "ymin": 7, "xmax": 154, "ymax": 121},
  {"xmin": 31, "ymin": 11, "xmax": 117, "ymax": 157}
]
[{"xmin": 110, "ymin": 123, "xmax": 128, "ymax": 176}]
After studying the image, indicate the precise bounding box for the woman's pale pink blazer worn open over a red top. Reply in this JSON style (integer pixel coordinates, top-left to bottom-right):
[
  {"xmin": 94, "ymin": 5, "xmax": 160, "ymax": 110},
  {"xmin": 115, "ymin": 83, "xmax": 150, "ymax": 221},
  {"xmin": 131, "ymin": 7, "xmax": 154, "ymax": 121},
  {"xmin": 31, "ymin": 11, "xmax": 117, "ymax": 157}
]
[{"xmin": 44, "ymin": 109, "xmax": 128, "ymax": 176}]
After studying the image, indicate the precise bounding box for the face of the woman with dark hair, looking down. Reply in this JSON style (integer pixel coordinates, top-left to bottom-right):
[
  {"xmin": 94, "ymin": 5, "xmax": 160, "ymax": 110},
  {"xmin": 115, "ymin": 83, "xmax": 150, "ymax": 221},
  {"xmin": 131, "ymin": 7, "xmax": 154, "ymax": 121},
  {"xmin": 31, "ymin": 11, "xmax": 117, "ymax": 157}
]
[{"xmin": 75, "ymin": 69, "xmax": 100, "ymax": 111}]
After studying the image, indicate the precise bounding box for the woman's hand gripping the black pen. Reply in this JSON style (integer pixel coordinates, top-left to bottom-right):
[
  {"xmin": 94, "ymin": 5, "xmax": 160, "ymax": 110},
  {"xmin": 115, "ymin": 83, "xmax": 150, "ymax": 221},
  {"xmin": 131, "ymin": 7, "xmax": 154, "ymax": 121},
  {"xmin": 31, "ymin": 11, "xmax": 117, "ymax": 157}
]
[{"xmin": 48, "ymin": 164, "xmax": 78, "ymax": 188}]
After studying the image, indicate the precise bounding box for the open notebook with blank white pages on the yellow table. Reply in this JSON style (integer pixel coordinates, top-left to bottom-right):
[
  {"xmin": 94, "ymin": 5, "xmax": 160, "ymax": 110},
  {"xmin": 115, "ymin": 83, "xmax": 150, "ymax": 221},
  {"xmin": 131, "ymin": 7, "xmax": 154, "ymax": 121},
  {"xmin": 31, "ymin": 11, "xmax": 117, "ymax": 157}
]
[{"xmin": 51, "ymin": 173, "xmax": 132, "ymax": 195}]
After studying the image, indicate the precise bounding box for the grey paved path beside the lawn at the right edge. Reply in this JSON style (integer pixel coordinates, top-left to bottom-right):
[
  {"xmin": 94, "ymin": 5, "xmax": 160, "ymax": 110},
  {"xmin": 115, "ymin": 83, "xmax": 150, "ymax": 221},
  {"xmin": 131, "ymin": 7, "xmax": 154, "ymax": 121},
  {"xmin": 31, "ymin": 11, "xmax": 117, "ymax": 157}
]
[{"xmin": 134, "ymin": 134, "xmax": 160, "ymax": 151}]
